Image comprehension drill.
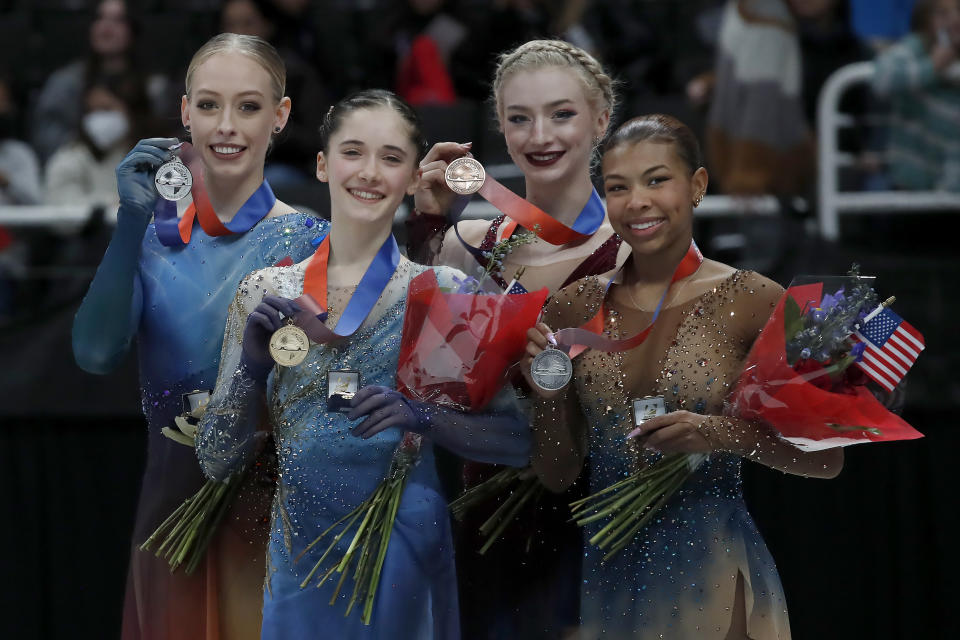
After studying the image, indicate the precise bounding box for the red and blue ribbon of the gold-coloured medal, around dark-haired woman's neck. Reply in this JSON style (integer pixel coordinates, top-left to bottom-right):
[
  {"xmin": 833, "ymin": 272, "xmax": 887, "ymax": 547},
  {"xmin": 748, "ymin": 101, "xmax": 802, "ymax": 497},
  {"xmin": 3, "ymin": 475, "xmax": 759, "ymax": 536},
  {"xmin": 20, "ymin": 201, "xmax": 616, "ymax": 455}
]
[{"xmin": 293, "ymin": 235, "xmax": 400, "ymax": 344}]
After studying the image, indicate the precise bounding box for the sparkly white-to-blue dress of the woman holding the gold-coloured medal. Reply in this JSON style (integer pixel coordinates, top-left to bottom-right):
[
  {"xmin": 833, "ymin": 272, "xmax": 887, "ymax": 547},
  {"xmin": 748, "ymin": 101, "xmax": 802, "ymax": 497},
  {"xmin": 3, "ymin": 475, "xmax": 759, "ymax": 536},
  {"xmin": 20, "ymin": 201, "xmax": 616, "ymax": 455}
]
[{"xmin": 198, "ymin": 259, "xmax": 515, "ymax": 639}]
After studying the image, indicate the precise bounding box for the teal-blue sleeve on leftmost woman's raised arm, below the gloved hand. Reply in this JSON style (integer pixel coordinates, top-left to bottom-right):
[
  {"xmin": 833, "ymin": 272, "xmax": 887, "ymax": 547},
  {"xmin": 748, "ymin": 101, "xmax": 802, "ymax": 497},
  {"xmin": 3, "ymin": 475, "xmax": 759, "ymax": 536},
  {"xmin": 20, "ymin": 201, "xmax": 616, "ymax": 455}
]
[{"xmin": 73, "ymin": 207, "xmax": 148, "ymax": 374}]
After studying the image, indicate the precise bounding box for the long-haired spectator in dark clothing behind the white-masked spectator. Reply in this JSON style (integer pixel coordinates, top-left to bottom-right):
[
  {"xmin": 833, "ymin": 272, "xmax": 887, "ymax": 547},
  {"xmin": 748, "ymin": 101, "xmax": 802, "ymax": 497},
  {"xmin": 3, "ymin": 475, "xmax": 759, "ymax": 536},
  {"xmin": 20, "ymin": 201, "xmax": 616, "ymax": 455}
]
[{"xmin": 31, "ymin": 0, "xmax": 157, "ymax": 161}]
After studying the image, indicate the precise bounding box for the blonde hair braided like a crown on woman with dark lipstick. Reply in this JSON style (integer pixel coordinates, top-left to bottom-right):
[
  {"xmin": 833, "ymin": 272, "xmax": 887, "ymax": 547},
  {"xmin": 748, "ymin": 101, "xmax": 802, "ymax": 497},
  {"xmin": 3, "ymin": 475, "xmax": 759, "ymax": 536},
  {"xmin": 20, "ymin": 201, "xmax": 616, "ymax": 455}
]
[{"xmin": 493, "ymin": 40, "xmax": 617, "ymax": 119}]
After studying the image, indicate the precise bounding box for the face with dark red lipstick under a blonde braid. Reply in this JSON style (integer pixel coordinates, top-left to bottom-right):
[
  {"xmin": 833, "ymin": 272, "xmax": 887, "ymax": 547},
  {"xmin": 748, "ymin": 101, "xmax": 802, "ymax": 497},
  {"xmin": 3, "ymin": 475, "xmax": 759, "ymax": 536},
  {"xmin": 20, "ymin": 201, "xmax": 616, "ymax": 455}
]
[{"xmin": 499, "ymin": 67, "xmax": 610, "ymax": 188}]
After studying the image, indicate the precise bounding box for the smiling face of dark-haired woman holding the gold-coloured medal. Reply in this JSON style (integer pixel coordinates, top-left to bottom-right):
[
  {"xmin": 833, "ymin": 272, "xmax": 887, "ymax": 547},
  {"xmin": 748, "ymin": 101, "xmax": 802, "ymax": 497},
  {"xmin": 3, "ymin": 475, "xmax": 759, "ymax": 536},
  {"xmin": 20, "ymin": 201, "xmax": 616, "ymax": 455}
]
[{"xmin": 317, "ymin": 106, "xmax": 420, "ymax": 230}]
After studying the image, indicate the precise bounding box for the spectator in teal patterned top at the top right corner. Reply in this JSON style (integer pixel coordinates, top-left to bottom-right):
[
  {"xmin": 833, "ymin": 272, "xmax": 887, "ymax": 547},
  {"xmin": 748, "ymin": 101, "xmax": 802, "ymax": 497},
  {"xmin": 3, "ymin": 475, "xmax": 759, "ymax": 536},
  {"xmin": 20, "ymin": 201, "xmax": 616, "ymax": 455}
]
[{"xmin": 873, "ymin": 0, "xmax": 960, "ymax": 192}]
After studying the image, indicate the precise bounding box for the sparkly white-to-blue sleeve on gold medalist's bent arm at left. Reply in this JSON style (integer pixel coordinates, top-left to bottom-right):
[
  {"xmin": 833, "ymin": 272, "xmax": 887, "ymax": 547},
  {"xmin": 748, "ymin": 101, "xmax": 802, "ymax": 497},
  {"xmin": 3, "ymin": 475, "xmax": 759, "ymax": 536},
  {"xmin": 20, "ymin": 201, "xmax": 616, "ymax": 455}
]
[{"xmin": 196, "ymin": 276, "xmax": 266, "ymax": 481}]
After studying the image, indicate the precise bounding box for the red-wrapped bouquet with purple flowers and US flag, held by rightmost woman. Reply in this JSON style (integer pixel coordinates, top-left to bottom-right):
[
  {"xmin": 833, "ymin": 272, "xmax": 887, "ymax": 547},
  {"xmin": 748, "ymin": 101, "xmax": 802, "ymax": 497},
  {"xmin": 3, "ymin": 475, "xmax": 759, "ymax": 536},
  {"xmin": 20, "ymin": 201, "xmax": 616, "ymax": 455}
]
[{"xmin": 571, "ymin": 265, "xmax": 923, "ymax": 560}]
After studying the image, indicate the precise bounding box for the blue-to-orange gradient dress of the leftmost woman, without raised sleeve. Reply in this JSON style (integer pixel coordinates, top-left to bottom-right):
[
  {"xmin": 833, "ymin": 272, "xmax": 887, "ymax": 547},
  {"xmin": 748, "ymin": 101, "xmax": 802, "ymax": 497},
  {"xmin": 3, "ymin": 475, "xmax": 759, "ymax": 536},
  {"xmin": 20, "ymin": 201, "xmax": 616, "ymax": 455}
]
[{"xmin": 74, "ymin": 213, "xmax": 328, "ymax": 640}]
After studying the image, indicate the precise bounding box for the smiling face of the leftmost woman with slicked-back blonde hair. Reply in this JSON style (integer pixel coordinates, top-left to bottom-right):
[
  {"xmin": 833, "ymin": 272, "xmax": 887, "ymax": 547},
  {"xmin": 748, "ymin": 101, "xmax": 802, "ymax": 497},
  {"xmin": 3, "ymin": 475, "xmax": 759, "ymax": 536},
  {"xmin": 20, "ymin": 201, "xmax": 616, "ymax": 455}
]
[{"xmin": 181, "ymin": 52, "xmax": 290, "ymax": 184}]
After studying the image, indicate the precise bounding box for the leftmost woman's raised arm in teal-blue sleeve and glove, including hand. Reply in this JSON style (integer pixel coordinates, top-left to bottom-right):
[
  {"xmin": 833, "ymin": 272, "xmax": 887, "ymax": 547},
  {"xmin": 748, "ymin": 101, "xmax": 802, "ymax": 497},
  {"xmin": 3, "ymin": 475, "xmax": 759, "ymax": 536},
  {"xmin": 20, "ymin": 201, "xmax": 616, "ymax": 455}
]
[{"xmin": 73, "ymin": 138, "xmax": 177, "ymax": 373}]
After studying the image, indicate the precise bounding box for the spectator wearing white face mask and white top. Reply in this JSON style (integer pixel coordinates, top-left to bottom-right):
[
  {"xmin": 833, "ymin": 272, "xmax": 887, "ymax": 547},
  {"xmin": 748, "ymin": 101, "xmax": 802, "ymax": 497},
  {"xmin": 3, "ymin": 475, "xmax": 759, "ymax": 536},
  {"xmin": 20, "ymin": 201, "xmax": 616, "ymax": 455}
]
[{"xmin": 44, "ymin": 73, "xmax": 148, "ymax": 209}]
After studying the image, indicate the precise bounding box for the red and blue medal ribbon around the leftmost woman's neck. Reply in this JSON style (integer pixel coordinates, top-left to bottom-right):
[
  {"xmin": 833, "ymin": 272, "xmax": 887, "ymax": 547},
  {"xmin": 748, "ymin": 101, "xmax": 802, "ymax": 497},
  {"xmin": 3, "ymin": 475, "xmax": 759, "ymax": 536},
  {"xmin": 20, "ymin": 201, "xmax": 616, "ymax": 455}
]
[{"xmin": 153, "ymin": 142, "xmax": 277, "ymax": 247}]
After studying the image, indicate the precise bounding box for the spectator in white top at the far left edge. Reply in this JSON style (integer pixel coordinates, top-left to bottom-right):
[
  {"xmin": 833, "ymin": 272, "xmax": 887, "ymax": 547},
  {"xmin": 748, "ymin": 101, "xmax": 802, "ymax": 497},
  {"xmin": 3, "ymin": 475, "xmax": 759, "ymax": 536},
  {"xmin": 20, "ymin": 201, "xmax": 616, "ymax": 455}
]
[{"xmin": 0, "ymin": 73, "xmax": 40, "ymax": 206}]
